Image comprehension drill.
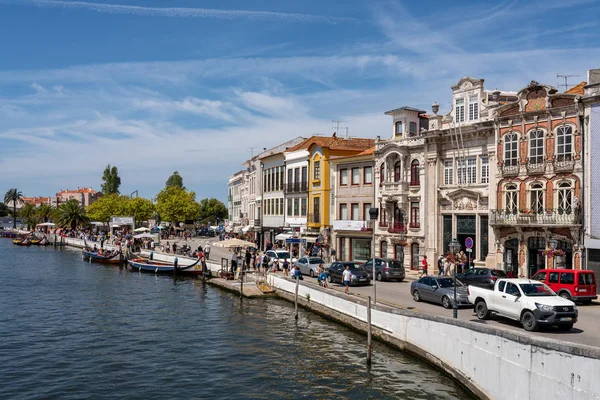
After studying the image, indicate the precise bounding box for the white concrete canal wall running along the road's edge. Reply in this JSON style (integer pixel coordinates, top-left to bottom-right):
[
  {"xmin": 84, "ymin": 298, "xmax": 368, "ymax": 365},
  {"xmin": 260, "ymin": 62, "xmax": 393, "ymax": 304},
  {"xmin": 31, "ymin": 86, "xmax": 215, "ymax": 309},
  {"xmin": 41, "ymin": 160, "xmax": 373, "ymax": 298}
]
[{"xmin": 269, "ymin": 276, "xmax": 600, "ymax": 400}]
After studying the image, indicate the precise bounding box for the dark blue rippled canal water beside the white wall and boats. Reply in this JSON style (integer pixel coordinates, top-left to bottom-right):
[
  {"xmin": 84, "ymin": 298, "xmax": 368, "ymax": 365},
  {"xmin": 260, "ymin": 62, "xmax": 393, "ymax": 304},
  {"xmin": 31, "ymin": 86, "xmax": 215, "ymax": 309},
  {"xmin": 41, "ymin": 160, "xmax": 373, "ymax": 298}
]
[{"xmin": 0, "ymin": 239, "xmax": 471, "ymax": 400}]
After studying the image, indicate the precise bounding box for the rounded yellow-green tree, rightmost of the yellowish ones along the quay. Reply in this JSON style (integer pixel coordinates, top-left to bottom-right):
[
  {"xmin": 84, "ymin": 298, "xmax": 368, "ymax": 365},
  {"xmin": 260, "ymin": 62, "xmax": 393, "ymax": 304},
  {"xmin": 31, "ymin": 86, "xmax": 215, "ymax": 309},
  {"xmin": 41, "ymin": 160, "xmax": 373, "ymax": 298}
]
[{"xmin": 156, "ymin": 186, "xmax": 200, "ymax": 224}]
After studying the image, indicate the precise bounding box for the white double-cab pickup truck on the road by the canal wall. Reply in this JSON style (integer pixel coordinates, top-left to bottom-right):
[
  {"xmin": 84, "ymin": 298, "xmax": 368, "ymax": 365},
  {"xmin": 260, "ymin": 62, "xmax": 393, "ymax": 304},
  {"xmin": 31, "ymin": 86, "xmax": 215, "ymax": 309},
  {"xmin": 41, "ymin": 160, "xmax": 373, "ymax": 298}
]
[{"xmin": 467, "ymin": 279, "xmax": 578, "ymax": 331}]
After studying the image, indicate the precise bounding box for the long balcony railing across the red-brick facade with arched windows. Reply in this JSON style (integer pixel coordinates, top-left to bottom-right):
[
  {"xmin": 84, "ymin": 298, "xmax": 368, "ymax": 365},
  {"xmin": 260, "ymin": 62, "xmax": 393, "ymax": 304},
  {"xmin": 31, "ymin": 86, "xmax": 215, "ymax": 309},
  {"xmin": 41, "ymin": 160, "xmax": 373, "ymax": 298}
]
[{"xmin": 490, "ymin": 209, "xmax": 581, "ymax": 226}]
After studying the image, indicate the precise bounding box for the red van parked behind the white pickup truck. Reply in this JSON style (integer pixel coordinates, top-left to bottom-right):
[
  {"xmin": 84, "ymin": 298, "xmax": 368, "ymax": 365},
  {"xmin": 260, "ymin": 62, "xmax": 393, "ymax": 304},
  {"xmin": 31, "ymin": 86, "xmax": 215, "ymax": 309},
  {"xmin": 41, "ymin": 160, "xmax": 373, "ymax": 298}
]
[{"xmin": 531, "ymin": 269, "xmax": 598, "ymax": 303}]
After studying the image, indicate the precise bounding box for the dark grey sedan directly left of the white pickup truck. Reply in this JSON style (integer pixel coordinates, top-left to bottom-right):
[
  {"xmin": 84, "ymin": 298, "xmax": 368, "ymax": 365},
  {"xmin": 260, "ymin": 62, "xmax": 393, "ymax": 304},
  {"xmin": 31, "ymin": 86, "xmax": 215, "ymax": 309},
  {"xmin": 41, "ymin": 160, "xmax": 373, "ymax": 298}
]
[{"xmin": 410, "ymin": 276, "xmax": 471, "ymax": 308}]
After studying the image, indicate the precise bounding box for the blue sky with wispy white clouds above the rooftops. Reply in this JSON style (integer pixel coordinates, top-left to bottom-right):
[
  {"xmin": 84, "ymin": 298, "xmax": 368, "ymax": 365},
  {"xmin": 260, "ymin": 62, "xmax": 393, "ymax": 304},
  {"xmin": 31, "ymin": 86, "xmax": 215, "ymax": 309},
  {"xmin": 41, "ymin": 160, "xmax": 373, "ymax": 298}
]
[{"xmin": 0, "ymin": 0, "xmax": 600, "ymax": 201}]
